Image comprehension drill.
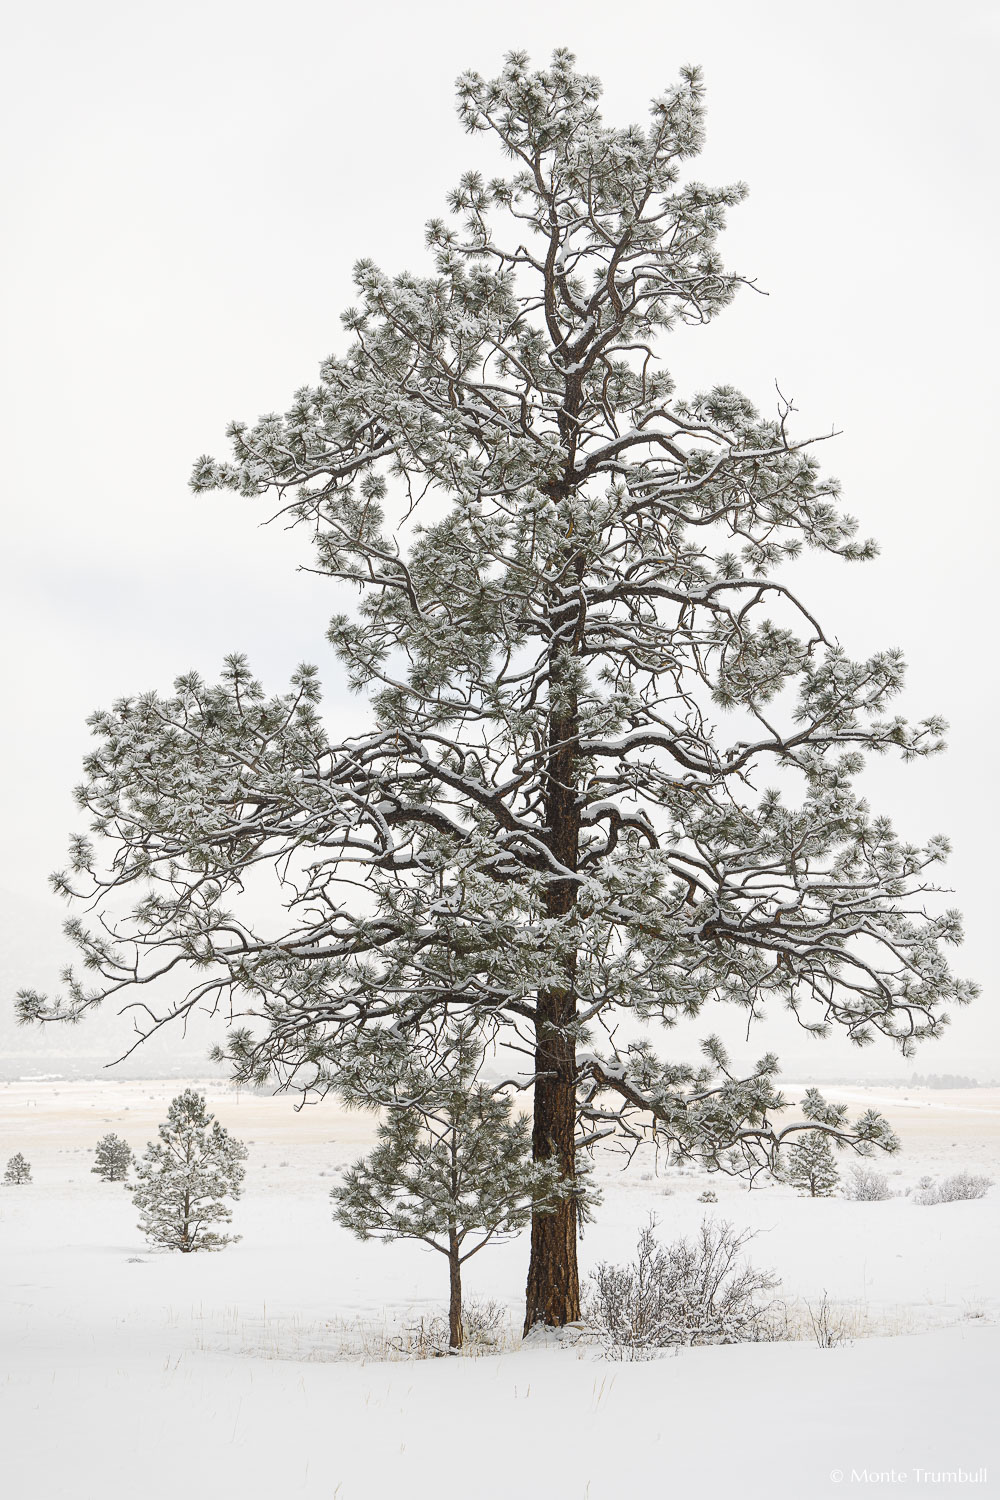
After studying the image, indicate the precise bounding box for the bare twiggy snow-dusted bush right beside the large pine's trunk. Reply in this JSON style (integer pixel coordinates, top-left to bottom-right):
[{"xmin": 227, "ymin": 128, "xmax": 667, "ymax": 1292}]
[{"xmin": 585, "ymin": 1217, "xmax": 778, "ymax": 1359}]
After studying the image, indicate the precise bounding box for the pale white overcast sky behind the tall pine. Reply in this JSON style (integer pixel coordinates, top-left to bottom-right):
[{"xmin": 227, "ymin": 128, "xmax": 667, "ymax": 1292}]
[{"xmin": 0, "ymin": 0, "xmax": 1000, "ymax": 1077}]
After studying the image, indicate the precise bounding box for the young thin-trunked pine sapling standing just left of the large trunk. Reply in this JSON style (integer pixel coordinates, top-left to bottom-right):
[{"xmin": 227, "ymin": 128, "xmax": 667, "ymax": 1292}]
[{"xmin": 330, "ymin": 1029, "xmax": 567, "ymax": 1350}]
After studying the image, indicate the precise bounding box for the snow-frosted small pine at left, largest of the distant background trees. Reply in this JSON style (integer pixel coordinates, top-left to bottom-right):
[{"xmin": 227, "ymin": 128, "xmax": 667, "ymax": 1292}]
[{"xmin": 132, "ymin": 1089, "xmax": 247, "ymax": 1253}]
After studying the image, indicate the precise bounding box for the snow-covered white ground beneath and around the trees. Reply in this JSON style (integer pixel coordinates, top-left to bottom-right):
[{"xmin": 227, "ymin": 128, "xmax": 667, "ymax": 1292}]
[{"xmin": 0, "ymin": 1080, "xmax": 1000, "ymax": 1500}]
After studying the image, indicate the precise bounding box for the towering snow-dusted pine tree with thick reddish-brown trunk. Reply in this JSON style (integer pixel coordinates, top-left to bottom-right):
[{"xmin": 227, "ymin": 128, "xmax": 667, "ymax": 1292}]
[{"xmin": 19, "ymin": 51, "xmax": 975, "ymax": 1325}]
